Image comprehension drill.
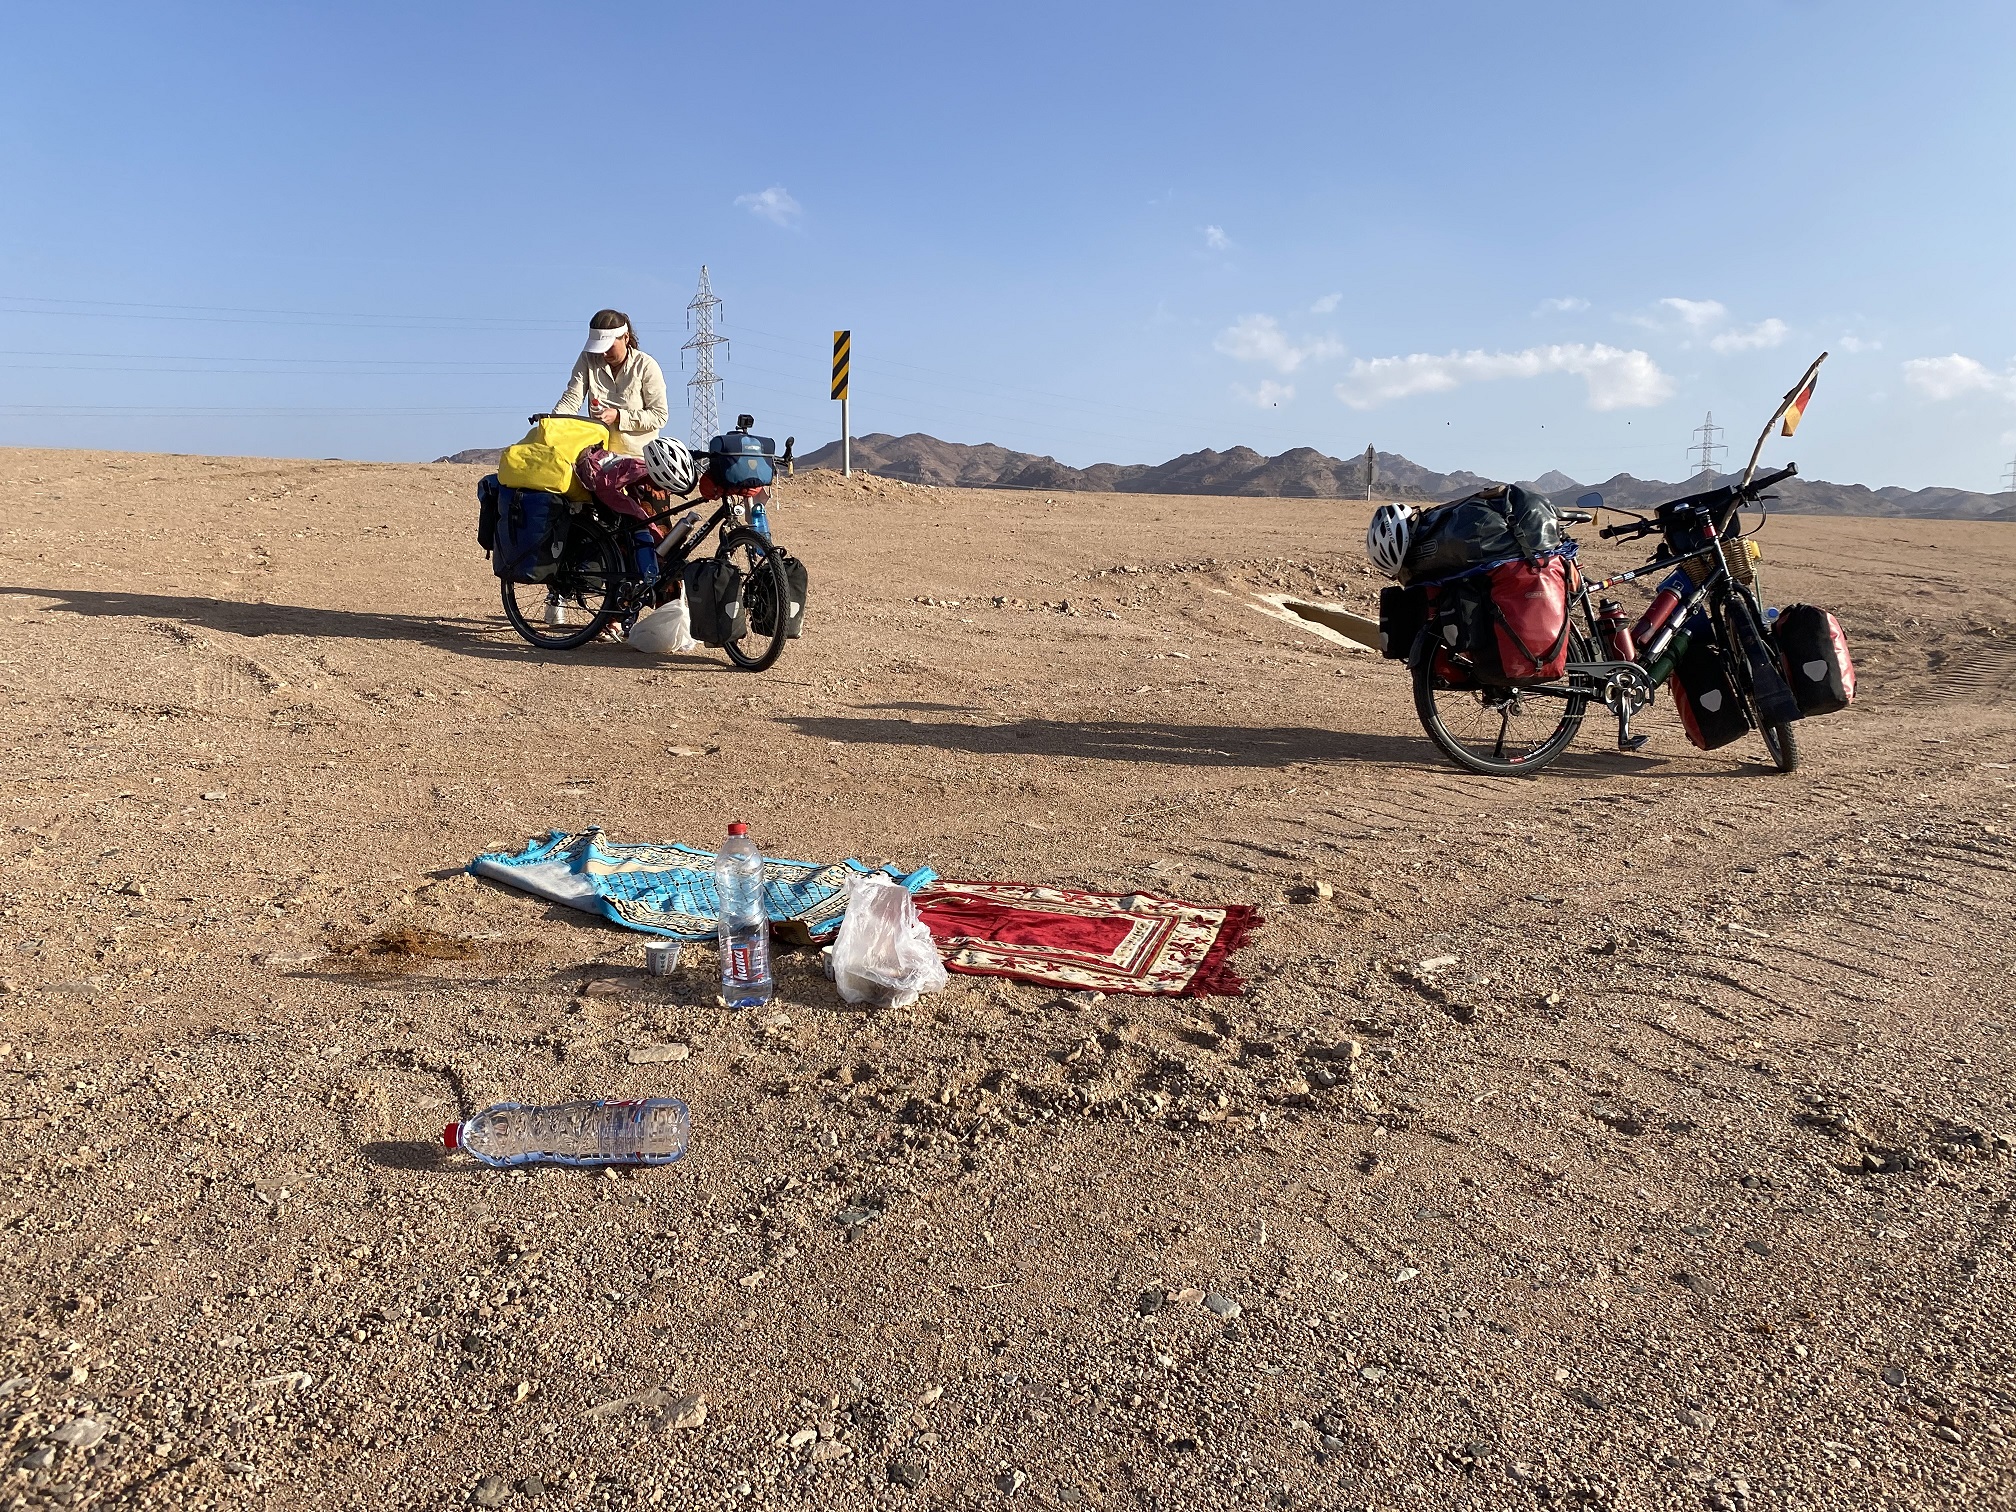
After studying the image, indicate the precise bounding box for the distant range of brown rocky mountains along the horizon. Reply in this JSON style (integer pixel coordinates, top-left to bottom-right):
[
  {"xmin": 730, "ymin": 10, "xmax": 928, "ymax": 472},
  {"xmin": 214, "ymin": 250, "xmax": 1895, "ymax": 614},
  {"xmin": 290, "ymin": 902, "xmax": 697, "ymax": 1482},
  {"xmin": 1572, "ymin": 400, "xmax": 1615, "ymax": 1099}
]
[{"xmin": 798, "ymin": 433, "xmax": 2016, "ymax": 520}]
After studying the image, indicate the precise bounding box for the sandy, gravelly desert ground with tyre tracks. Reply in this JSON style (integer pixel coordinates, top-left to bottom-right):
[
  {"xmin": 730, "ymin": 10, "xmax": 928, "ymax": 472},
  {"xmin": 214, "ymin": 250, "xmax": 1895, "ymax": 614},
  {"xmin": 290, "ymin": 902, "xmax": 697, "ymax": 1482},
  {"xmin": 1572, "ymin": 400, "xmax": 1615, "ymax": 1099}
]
[{"xmin": 0, "ymin": 450, "xmax": 2016, "ymax": 1512}]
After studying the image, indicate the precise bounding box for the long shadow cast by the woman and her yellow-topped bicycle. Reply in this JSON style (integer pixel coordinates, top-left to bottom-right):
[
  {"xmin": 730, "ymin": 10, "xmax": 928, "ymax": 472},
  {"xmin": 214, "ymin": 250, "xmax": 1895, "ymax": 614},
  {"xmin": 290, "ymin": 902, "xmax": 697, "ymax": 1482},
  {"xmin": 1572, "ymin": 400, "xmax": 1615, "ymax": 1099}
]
[{"xmin": 0, "ymin": 583, "xmax": 745, "ymax": 669}]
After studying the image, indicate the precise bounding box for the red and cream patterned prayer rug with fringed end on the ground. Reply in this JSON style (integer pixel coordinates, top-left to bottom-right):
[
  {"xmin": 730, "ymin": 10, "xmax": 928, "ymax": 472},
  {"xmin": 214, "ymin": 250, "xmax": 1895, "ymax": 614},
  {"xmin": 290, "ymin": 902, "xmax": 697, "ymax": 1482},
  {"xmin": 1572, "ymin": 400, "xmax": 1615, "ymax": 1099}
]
[{"xmin": 917, "ymin": 881, "xmax": 1260, "ymax": 998}]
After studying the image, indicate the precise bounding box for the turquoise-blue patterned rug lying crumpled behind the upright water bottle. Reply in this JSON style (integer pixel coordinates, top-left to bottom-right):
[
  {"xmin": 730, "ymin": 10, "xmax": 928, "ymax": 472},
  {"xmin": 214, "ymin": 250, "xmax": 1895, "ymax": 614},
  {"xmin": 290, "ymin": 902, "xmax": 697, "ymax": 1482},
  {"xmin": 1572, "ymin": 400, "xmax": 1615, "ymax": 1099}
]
[{"xmin": 470, "ymin": 829, "xmax": 937, "ymax": 939}]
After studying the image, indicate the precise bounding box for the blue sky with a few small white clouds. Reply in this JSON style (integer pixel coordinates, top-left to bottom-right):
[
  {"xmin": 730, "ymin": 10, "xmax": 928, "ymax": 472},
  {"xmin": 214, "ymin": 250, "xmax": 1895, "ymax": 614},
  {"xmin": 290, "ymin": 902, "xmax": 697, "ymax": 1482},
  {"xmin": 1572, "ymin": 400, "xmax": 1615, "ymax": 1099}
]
[{"xmin": 0, "ymin": 0, "xmax": 2016, "ymax": 492}]
